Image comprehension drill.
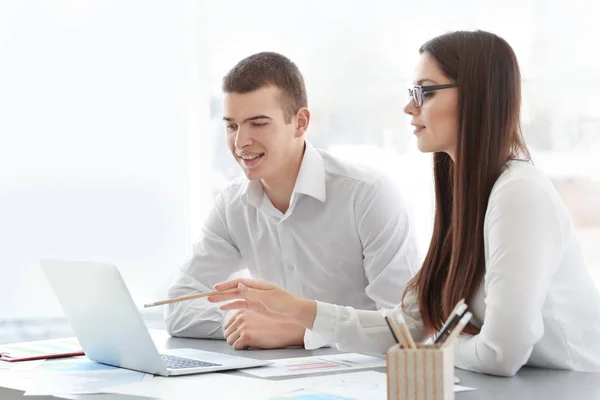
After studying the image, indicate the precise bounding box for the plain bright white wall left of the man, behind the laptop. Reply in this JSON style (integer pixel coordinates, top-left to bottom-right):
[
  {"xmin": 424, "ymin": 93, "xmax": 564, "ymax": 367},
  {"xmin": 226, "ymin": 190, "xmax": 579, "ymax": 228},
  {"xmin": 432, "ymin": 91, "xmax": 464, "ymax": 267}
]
[{"xmin": 0, "ymin": 0, "xmax": 202, "ymax": 319}]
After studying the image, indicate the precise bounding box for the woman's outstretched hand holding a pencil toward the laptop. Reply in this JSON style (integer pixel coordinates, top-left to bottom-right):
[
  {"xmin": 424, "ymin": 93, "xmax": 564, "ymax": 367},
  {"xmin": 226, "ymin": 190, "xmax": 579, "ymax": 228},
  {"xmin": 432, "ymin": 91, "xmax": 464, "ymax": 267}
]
[{"xmin": 208, "ymin": 279, "xmax": 317, "ymax": 329}]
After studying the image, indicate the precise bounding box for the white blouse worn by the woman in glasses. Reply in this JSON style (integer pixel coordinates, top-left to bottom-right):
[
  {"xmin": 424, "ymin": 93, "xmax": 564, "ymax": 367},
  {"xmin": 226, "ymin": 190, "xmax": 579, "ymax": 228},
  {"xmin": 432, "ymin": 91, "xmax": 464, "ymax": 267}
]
[{"xmin": 305, "ymin": 161, "xmax": 600, "ymax": 376}]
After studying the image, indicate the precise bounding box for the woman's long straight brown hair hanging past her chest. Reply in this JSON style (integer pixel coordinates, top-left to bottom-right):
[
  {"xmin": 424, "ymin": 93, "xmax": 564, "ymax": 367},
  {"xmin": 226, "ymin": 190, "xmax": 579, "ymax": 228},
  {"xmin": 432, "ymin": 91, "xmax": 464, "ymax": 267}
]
[{"xmin": 407, "ymin": 31, "xmax": 530, "ymax": 334}]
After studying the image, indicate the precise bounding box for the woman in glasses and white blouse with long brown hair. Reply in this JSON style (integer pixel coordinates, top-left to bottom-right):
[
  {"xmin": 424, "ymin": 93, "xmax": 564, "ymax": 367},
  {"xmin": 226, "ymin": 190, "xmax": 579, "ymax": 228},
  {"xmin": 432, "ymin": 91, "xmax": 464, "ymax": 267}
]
[{"xmin": 210, "ymin": 31, "xmax": 600, "ymax": 376}]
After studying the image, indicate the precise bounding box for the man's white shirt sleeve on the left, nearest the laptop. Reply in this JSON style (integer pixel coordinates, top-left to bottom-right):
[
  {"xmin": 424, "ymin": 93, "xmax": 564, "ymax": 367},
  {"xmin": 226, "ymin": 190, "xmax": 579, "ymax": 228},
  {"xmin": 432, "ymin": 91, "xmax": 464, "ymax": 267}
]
[{"xmin": 165, "ymin": 193, "xmax": 243, "ymax": 339}]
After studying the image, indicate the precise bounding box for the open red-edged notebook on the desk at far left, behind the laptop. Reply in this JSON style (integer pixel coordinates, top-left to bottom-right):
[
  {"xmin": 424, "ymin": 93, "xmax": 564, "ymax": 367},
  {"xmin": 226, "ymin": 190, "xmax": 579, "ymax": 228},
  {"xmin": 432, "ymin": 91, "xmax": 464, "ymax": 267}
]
[{"xmin": 0, "ymin": 338, "xmax": 85, "ymax": 362}]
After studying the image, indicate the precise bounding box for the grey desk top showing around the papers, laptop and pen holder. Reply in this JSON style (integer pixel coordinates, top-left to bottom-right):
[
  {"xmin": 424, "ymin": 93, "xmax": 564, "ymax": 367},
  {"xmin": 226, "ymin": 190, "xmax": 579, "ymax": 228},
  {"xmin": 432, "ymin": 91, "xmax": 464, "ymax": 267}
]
[{"xmin": 0, "ymin": 331, "xmax": 600, "ymax": 400}]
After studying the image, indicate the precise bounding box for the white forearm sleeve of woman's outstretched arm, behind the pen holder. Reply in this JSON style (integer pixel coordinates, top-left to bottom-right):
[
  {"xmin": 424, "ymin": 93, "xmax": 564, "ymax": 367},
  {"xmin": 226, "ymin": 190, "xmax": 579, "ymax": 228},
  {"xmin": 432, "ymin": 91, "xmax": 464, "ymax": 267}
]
[{"xmin": 305, "ymin": 291, "xmax": 426, "ymax": 353}]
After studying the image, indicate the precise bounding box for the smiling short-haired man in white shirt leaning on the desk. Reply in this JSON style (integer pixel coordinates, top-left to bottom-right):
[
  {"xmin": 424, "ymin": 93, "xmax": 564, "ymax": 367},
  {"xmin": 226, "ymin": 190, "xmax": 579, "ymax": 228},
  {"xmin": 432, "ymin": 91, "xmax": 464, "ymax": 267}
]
[{"xmin": 165, "ymin": 53, "xmax": 419, "ymax": 349}]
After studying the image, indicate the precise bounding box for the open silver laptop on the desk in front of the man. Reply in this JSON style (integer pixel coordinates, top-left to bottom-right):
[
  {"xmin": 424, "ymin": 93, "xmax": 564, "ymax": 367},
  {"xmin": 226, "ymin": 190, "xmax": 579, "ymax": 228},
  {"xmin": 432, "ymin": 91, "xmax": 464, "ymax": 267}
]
[{"xmin": 41, "ymin": 260, "xmax": 271, "ymax": 376}]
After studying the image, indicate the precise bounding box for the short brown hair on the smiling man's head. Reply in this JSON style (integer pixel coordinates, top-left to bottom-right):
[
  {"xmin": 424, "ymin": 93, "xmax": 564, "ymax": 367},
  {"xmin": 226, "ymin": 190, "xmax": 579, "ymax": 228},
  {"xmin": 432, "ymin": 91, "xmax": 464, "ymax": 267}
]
[{"xmin": 223, "ymin": 52, "xmax": 308, "ymax": 123}]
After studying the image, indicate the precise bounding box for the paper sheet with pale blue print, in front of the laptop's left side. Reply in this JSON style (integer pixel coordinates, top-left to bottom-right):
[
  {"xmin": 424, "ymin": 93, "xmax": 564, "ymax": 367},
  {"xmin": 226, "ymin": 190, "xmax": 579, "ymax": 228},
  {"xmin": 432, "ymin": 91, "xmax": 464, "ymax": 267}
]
[{"xmin": 25, "ymin": 357, "xmax": 153, "ymax": 396}]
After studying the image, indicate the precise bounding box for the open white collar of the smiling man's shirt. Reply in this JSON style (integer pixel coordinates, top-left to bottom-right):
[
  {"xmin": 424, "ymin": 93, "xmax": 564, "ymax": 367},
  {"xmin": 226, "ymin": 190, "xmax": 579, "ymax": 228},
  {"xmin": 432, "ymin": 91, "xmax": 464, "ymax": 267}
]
[{"xmin": 244, "ymin": 141, "xmax": 327, "ymax": 209}]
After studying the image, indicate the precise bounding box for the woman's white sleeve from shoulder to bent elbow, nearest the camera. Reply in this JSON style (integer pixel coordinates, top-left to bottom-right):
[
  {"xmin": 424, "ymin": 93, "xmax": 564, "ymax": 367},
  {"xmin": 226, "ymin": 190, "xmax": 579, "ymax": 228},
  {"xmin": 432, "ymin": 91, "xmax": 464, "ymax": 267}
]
[{"xmin": 455, "ymin": 179, "xmax": 563, "ymax": 376}]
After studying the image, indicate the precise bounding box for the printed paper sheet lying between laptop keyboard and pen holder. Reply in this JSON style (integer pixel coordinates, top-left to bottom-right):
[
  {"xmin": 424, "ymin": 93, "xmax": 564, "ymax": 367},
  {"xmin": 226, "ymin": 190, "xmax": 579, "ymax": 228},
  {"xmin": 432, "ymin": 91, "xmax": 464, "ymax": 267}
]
[{"xmin": 242, "ymin": 353, "xmax": 385, "ymax": 378}]
